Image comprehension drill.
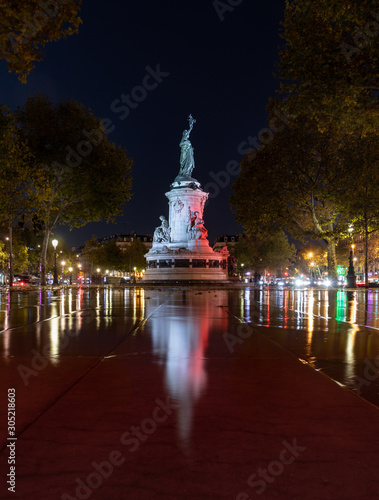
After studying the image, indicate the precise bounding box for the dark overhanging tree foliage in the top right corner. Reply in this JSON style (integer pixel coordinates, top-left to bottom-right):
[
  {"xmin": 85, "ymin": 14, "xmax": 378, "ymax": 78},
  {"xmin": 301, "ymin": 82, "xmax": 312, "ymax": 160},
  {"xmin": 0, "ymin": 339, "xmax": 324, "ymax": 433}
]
[{"xmin": 279, "ymin": 0, "xmax": 379, "ymax": 131}]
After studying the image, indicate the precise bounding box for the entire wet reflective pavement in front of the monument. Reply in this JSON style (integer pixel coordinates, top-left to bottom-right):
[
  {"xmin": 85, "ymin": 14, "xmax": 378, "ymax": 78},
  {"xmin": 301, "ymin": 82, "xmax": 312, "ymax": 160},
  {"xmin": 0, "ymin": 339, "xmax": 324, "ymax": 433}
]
[{"xmin": 0, "ymin": 287, "xmax": 379, "ymax": 500}]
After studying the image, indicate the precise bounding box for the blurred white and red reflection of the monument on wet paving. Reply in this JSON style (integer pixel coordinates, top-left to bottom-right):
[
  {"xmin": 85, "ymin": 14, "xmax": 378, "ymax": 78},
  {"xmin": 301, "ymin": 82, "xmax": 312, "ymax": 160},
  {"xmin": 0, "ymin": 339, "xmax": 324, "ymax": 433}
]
[{"xmin": 146, "ymin": 291, "xmax": 229, "ymax": 451}]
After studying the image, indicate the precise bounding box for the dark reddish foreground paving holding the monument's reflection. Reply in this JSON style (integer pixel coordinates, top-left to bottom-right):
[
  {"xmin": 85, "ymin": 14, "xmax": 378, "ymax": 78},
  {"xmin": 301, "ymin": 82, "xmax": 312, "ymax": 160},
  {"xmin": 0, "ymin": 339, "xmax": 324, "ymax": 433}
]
[{"xmin": 0, "ymin": 291, "xmax": 379, "ymax": 500}]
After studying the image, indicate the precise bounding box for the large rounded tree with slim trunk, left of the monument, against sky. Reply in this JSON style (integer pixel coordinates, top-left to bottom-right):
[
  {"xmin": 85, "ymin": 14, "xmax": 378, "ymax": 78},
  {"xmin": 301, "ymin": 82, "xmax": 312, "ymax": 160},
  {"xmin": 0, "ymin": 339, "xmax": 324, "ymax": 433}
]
[{"xmin": 16, "ymin": 95, "xmax": 132, "ymax": 284}]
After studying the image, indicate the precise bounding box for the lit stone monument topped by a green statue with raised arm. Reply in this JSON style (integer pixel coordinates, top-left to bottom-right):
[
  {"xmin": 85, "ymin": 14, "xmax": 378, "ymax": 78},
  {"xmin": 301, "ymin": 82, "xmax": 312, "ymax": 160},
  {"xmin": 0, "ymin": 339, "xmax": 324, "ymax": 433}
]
[{"xmin": 144, "ymin": 115, "xmax": 228, "ymax": 282}]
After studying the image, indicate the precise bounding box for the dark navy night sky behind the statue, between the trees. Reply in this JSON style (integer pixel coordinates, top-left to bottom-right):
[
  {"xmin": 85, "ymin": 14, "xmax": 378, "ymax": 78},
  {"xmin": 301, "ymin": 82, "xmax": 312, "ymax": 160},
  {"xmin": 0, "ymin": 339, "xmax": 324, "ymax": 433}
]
[{"xmin": 0, "ymin": 0, "xmax": 284, "ymax": 246}]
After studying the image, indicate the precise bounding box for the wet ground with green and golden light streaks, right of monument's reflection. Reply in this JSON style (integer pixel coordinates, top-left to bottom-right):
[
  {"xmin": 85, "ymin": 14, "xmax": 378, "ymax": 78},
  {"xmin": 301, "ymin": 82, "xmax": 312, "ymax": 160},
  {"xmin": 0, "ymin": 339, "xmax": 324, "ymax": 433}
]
[{"xmin": 237, "ymin": 288, "xmax": 379, "ymax": 406}]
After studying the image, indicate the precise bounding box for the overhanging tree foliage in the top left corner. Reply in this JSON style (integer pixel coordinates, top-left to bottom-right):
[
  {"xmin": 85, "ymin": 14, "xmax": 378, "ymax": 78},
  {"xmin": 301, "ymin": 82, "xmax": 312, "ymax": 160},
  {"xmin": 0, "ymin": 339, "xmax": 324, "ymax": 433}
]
[{"xmin": 0, "ymin": 0, "xmax": 82, "ymax": 83}]
